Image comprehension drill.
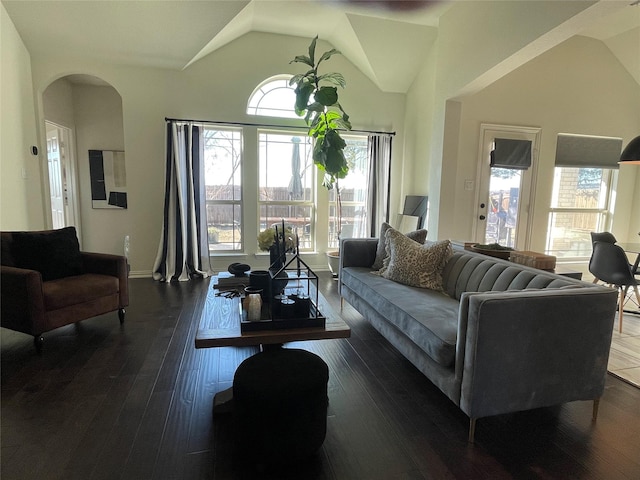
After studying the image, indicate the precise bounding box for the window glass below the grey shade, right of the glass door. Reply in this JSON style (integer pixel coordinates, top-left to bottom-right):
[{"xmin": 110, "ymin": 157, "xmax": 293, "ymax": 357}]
[{"xmin": 547, "ymin": 167, "xmax": 613, "ymax": 259}]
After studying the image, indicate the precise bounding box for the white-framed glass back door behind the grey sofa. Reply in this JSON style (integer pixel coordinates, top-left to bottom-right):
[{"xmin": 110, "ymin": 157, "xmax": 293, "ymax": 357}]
[{"xmin": 475, "ymin": 124, "xmax": 540, "ymax": 250}]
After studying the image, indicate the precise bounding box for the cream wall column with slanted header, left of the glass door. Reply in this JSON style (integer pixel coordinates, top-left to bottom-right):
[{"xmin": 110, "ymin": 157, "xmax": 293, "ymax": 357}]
[{"xmin": 416, "ymin": 1, "xmax": 626, "ymax": 238}]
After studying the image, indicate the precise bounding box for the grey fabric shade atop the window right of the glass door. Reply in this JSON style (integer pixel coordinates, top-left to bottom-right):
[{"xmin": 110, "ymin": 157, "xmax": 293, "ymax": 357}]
[{"xmin": 556, "ymin": 133, "xmax": 622, "ymax": 168}]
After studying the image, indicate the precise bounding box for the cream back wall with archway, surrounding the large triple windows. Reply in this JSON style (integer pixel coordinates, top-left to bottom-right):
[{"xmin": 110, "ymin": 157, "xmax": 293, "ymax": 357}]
[{"xmin": 32, "ymin": 33, "xmax": 404, "ymax": 274}]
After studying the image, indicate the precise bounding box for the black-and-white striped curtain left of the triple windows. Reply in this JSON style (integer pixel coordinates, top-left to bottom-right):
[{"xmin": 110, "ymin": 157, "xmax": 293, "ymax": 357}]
[{"xmin": 153, "ymin": 121, "xmax": 211, "ymax": 282}]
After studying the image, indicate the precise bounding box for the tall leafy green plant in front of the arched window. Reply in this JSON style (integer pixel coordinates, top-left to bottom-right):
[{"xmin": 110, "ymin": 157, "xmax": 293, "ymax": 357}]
[{"xmin": 289, "ymin": 36, "xmax": 351, "ymax": 189}]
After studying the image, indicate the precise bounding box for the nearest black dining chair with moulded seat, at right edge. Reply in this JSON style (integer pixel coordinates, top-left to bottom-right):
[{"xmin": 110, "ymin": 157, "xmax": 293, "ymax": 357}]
[{"xmin": 589, "ymin": 241, "xmax": 640, "ymax": 333}]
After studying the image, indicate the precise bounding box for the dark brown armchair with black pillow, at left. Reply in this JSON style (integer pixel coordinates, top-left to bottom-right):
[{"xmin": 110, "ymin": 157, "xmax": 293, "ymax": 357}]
[{"xmin": 0, "ymin": 227, "xmax": 129, "ymax": 353}]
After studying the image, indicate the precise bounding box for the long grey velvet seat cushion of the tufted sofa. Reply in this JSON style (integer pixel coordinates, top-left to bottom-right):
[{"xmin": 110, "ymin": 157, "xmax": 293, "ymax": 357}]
[{"xmin": 341, "ymin": 267, "xmax": 460, "ymax": 367}]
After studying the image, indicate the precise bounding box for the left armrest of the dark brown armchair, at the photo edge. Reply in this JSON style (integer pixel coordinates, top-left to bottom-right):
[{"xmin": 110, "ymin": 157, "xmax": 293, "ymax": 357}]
[{"xmin": 0, "ymin": 265, "xmax": 46, "ymax": 335}]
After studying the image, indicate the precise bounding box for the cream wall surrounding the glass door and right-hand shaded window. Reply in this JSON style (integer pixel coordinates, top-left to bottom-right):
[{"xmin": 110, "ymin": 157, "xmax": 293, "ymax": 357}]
[{"xmin": 452, "ymin": 37, "xmax": 640, "ymax": 251}]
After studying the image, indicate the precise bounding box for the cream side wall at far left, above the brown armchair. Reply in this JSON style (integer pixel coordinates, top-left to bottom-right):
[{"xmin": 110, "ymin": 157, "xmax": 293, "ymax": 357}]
[{"xmin": 0, "ymin": 5, "xmax": 46, "ymax": 230}]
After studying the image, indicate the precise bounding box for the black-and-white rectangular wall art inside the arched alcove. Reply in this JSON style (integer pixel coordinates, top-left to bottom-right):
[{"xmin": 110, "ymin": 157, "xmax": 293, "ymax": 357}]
[{"xmin": 89, "ymin": 150, "xmax": 127, "ymax": 209}]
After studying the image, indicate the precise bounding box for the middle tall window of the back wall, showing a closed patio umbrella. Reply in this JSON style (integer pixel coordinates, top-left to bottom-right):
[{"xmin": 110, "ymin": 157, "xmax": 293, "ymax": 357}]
[{"xmin": 258, "ymin": 131, "xmax": 316, "ymax": 251}]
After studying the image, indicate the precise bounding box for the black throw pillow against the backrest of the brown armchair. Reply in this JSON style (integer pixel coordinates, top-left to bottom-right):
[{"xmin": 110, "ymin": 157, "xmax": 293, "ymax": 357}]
[{"xmin": 12, "ymin": 227, "xmax": 83, "ymax": 282}]
